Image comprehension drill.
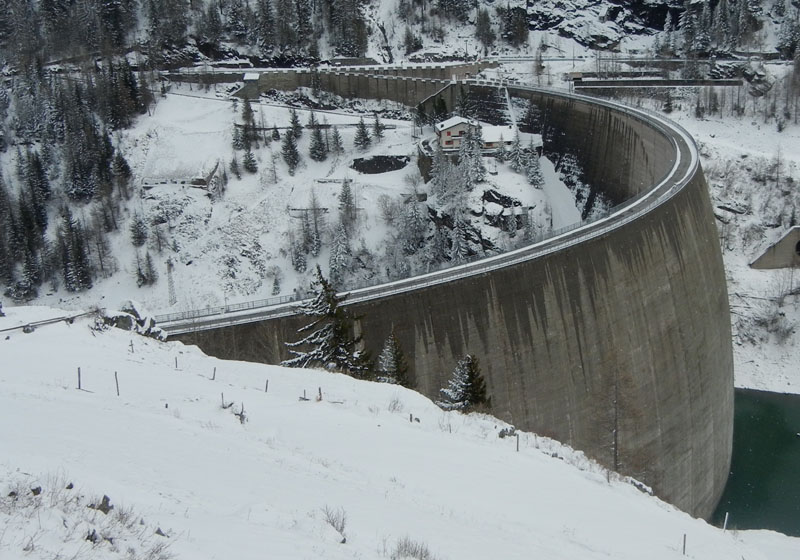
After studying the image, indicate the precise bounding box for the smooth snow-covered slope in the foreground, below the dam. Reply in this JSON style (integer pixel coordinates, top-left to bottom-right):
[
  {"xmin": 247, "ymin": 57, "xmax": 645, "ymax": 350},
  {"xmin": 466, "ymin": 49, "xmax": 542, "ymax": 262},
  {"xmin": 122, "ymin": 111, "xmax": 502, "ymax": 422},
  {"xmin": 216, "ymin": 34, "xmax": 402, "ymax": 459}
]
[{"xmin": 0, "ymin": 307, "xmax": 800, "ymax": 560}]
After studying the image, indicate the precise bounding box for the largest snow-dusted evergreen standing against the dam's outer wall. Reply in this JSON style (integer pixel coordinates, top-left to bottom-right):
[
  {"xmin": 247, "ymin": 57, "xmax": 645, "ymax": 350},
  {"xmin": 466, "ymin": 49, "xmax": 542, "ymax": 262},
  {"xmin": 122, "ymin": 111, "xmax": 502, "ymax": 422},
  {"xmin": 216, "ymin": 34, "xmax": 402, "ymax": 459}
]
[{"xmin": 281, "ymin": 265, "xmax": 370, "ymax": 377}]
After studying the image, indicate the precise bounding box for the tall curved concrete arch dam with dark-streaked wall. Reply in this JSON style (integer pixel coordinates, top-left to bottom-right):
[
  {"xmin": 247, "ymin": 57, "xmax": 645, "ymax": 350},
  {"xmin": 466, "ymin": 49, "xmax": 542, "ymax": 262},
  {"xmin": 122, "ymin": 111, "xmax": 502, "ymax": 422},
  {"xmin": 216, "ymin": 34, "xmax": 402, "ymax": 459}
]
[{"xmin": 165, "ymin": 82, "xmax": 733, "ymax": 517}]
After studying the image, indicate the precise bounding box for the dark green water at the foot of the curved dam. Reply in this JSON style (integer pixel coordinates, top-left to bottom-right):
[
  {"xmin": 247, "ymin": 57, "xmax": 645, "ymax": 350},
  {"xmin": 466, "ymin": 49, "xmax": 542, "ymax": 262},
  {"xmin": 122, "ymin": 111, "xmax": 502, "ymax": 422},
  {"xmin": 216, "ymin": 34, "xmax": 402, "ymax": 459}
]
[{"xmin": 712, "ymin": 389, "xmax": 800, "ymax": 537}]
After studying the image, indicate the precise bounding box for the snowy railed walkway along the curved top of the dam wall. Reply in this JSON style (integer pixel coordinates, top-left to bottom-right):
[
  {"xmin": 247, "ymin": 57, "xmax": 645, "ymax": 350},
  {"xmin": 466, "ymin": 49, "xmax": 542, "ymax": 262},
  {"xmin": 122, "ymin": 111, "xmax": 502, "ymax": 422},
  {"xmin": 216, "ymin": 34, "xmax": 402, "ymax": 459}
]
[{"xmin": 154, "ymin": 80, "xmax": 698, "ymax": 332}]
